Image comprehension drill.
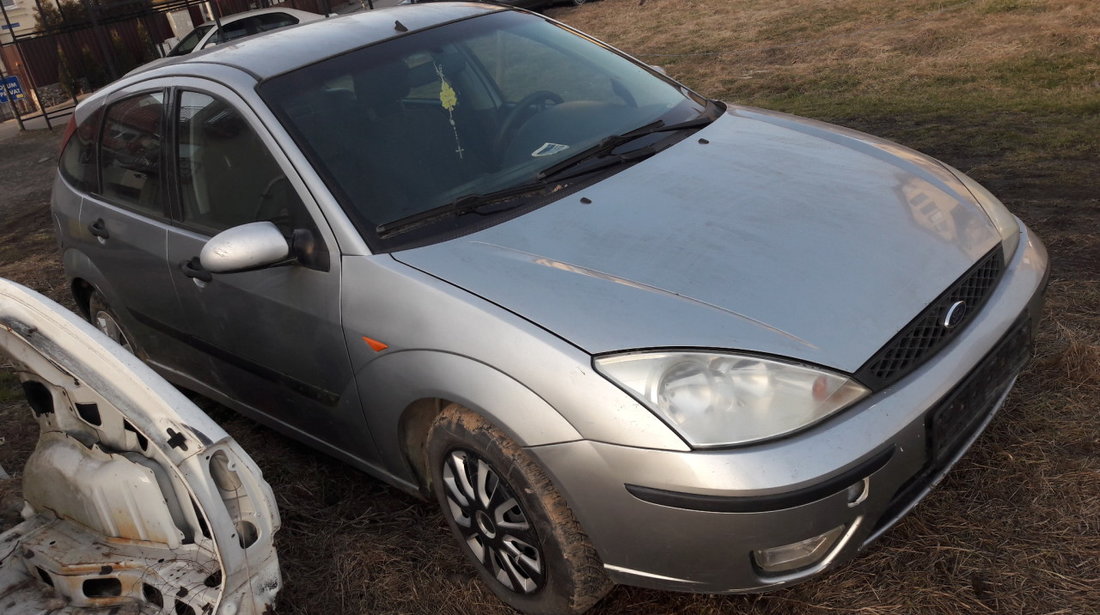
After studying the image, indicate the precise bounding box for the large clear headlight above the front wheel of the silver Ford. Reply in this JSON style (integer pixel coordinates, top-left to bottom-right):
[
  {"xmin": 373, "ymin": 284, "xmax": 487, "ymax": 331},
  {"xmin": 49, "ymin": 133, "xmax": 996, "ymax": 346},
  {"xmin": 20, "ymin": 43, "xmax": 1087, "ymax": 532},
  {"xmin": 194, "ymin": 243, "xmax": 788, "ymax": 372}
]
[{"xmin": 595, "ymin": 352, "xmax": 868, "ymax": 448}]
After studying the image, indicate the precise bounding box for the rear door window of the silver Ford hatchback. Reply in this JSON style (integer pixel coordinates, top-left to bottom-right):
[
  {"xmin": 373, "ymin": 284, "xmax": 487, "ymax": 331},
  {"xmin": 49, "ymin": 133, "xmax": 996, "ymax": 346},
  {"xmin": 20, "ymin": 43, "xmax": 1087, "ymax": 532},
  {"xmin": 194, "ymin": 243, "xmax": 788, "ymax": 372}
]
[{"xmin": 99, "ymin": 92, "xmax": 164, "ymax": 216}]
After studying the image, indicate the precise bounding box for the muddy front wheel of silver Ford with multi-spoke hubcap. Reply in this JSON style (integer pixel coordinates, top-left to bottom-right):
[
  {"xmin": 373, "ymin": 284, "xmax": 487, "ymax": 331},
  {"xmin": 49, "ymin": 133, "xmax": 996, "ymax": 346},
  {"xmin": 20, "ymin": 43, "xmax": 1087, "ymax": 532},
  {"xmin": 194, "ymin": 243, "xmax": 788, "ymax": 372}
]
[{"xmin": 426, "ymin": 404, "xmax": 612, "ymax": 615}]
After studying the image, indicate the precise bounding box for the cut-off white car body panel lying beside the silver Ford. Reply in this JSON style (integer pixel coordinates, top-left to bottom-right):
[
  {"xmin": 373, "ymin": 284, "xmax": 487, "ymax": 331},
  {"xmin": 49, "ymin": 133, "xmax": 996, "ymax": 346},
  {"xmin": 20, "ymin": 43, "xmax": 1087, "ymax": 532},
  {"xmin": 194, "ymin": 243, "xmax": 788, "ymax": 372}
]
[{"xmin": 0, "ymin": 279, "xmax": 282, "ymax": 615}]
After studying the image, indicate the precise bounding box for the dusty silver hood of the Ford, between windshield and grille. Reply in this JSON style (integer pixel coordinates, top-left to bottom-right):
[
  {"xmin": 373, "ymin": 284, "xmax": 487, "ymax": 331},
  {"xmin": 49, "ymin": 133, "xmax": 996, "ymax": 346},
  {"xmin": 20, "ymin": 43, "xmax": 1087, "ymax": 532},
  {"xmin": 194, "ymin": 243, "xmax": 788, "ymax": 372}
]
[{"xmin": 394, "ymin": 107, "xmax": 1000, "ymax": 372}]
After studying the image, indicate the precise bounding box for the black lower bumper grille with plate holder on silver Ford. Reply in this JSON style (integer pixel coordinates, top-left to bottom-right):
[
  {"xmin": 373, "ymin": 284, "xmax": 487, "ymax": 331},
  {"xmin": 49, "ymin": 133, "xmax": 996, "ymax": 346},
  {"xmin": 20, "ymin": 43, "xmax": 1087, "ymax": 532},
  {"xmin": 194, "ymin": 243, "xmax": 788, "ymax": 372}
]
[{"xmin": 872, "ymin": 312, "xmax": 1033, "ymax": 535}]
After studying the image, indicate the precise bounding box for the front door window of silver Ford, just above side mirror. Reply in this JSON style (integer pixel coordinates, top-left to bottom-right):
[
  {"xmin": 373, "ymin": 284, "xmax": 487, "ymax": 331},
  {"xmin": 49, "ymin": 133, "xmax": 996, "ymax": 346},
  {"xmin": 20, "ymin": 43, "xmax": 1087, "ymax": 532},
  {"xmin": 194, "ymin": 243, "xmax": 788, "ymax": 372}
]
[{"xmin": 176, "ymin": 91, "xmax": 308, "ymax": 234}]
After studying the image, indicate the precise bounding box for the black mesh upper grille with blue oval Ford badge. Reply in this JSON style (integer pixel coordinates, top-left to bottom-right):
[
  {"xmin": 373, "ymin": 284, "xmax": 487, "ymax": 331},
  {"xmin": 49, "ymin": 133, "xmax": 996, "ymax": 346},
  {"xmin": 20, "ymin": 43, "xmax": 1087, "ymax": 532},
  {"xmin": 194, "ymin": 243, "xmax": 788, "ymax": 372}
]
[{"xmin": 855, "ymin": 245, "xmax": 1004, "ymax": 391}]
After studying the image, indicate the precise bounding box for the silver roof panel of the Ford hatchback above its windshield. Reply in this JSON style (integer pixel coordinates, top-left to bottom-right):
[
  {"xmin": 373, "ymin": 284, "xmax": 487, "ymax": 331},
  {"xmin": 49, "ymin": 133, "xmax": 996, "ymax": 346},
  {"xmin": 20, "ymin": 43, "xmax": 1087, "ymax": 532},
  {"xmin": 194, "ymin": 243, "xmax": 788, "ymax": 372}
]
[{"xmin": 169, "ymin": 2, "xmax": 510, "ymax": 80}]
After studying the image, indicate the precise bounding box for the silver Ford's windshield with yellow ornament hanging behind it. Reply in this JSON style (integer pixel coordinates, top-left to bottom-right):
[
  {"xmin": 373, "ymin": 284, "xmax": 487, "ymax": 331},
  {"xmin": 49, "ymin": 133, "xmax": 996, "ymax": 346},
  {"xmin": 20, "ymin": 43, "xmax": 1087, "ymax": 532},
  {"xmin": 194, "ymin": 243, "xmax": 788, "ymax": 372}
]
[{"xmin": 260, "ymin": 12, "xmax": 707, "ymax": 250}]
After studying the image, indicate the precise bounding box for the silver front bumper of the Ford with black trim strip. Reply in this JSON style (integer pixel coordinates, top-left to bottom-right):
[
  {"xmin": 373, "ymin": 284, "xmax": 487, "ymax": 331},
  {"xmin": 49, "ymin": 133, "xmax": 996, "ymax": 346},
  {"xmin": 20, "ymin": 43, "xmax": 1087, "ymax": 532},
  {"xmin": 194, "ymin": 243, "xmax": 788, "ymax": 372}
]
[{"xmin": 529, "ymin": 224, "xmax": 1047, "ymax": 593}]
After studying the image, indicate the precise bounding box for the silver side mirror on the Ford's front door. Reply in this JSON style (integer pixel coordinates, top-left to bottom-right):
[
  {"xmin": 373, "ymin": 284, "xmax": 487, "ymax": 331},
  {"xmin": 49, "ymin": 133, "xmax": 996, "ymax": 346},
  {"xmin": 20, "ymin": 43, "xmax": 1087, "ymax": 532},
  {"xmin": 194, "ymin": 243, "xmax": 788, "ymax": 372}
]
[{"xmin": 199, "ymin": 222, "xmax": 290, "ymax": 273}]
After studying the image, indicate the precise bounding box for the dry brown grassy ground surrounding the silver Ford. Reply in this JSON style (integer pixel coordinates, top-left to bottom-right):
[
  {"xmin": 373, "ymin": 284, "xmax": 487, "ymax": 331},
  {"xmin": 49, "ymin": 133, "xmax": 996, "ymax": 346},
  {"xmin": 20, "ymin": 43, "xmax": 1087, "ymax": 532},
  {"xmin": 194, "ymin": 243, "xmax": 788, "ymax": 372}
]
[{"xmin": 0, "ymin": 0, "xmax": 1100, "ymax": 615}]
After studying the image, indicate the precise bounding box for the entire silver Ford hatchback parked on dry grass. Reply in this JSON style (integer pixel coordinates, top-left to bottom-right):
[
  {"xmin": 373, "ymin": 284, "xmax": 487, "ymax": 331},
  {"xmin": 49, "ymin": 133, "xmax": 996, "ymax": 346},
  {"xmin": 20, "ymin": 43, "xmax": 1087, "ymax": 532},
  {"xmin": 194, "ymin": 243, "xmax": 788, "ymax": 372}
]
[{"xmin": 53, "ymin": 3, "xmax": 1047, "ymax": 613}]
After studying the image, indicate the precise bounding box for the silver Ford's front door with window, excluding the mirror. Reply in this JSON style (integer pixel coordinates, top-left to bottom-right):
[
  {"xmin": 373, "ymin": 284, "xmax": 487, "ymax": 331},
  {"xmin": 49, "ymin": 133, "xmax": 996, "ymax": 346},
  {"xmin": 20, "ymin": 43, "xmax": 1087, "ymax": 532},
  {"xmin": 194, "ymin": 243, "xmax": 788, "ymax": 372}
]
[{"xmin": 161, "ymin": 80, "xmax": 374, "ymax": 460}]
